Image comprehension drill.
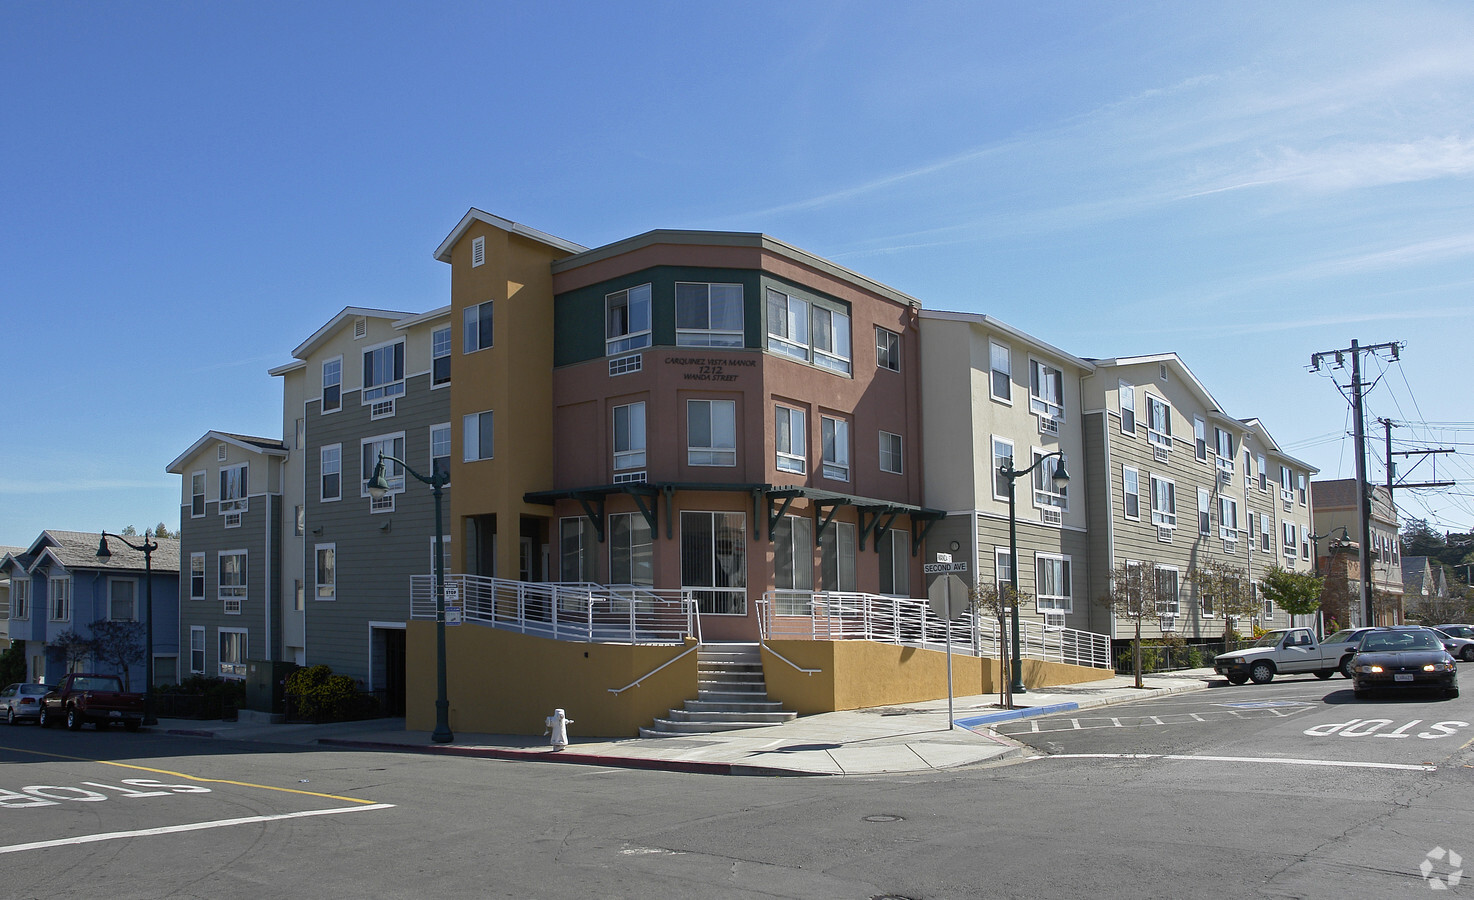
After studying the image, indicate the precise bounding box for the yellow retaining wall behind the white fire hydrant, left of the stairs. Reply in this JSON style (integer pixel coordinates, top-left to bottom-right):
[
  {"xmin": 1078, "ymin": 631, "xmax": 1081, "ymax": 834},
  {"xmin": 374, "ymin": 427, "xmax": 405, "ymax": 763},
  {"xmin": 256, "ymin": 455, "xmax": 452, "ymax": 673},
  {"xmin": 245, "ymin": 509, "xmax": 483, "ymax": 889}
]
[{"xmin": 405, "ymin": 622, "xmax": 696, "ymax": 738}]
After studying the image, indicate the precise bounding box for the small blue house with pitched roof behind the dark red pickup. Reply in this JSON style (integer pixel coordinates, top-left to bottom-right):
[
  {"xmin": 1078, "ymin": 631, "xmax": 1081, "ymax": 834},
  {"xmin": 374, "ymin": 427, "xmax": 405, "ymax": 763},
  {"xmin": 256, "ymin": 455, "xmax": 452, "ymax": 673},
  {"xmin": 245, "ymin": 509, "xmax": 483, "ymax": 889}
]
[{"xmin": 0, "ymin": 530, "xmax": 180, "ymax": 691}]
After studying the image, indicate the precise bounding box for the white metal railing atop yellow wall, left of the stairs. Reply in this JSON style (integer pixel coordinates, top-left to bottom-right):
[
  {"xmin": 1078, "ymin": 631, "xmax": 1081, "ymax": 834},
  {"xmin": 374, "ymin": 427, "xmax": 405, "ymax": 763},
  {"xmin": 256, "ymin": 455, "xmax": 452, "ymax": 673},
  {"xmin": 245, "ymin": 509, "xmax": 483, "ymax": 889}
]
[{"xmin": 410, "ymin": 574, "xmax": 702, "ymax": 644}]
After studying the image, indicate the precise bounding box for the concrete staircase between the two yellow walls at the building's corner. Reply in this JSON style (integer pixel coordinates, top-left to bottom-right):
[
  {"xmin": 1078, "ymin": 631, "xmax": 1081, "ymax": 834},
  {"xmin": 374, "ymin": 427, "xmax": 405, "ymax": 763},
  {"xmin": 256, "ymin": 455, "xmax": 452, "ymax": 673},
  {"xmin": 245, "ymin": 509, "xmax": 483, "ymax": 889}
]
[{"xmin": 640, "ymin": 644, "xmax": 797, "ymax": 738}]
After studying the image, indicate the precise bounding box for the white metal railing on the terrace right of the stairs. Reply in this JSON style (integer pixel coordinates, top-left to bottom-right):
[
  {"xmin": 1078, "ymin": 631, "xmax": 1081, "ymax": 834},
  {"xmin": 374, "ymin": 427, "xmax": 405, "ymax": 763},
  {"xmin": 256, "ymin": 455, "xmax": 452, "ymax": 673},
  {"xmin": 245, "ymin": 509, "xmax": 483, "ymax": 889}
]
[{"xmin": 758, "ymin": 591, "xmax": 1111, "ymax": 669}]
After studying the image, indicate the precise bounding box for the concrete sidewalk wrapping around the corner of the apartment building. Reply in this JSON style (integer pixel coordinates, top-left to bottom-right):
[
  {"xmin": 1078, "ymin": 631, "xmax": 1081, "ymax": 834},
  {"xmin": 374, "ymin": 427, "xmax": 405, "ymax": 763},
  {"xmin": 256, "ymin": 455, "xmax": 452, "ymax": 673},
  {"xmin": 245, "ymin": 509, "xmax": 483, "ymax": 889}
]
[{"xmin": 155, "ymin": 669, "xmax": 1213, "ymax": 775}]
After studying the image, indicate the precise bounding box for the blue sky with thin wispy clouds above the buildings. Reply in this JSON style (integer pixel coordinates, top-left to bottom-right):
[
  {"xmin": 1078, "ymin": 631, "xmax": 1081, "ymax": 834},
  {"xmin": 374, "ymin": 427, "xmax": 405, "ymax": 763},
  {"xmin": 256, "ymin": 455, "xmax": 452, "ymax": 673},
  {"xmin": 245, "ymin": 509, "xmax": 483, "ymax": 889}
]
[{"xmin": 0, "ymin": 1, "xmax": 1474, "ymax": 545}]
